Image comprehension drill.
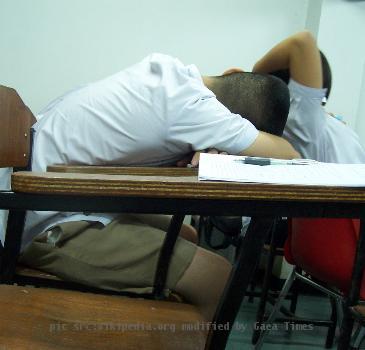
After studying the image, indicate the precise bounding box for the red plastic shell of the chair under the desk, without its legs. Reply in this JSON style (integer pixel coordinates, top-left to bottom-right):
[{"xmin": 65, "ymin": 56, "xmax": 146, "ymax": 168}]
[{"xmin": 284, "ymin": 218, "xmax": 365, "ymax": 299}]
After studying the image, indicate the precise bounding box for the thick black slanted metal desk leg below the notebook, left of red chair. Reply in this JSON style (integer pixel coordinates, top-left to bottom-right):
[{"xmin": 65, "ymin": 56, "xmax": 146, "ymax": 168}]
[{"xmin": 205, "ymin": 217, "xmax": 274, "ymax": 350}]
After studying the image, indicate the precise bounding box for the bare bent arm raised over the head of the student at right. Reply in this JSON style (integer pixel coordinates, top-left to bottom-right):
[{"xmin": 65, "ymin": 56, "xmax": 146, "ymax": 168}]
[{"xmin": 252, "ymin": 31, "xmax": 323, "ymax": 88}]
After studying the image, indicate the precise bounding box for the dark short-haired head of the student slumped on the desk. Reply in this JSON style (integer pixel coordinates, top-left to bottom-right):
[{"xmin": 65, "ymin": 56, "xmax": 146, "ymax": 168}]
[{"xmin": 204, "ymin": 71, "xmax": 290, "ymax": 135}]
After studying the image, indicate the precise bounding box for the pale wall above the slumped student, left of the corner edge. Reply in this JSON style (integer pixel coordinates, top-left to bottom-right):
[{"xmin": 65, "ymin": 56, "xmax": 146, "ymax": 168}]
[{"xmin": 0, "ymin": 0, "xmax": 312, "ymax": 113}]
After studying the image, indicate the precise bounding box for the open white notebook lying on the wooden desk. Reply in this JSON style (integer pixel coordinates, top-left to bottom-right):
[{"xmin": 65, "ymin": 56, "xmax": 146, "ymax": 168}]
[{"xmin": 199, "ymin": 153, "xmax": 365, "ymax": 187}]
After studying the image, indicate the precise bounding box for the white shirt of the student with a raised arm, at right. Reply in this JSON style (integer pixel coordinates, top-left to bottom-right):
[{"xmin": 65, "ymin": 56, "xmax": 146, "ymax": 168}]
[{"xmin": 283, "ymin": 79, "xmax": 365, "ymax": 163}]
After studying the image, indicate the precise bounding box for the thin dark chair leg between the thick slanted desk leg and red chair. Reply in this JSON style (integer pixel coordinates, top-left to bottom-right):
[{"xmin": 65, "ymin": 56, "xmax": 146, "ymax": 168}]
[{"xmin": 251, "ymin": 225, "xmax": 276, "ymax": 344}]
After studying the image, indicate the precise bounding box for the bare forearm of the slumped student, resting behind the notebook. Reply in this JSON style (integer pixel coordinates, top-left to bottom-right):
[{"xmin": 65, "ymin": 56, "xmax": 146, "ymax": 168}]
[{"xmin": 240, "ymin": 131, "xmax": 301, "ymax": 159}]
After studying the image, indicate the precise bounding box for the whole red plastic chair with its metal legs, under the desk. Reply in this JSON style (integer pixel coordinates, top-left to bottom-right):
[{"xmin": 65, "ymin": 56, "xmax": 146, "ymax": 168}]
[{"xmin": 255, "ymin": 218, "xmax": 365, "ymax": 350}]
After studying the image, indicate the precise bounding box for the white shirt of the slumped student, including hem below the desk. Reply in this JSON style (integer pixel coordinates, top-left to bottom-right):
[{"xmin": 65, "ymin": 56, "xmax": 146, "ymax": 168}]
[{"xmin": 22, "ymin": 54, "xmax": 258, "ymax": 247}]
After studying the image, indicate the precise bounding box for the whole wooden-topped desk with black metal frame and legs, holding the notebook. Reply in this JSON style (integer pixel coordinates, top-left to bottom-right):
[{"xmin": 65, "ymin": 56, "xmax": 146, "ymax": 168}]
[{"xmin": 0, "ymin": 167, "xmax": 365, "ymax": 350}]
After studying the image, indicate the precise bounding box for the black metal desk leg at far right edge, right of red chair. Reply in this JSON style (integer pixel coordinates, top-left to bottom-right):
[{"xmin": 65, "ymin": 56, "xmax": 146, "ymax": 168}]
[{"xmin": 337, "ymin": 219, "xmax": 365, "ymax": 350}]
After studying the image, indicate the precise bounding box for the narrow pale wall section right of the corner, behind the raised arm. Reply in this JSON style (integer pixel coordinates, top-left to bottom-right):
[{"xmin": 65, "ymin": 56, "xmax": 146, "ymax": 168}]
[{"xmin": 318, "ymin": 0, "xmax": 365, "ymax": 135}]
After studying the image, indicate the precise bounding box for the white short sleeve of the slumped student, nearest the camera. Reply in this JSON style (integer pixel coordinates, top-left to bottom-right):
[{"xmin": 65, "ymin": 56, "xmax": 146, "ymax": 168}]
[{"xmin": 168, "ymin": 90, "xmax": 259, "ymax": 154}]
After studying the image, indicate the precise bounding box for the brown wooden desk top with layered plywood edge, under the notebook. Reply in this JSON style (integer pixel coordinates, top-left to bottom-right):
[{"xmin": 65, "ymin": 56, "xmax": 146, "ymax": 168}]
[{"xmin": 12, "ymin": 167, "xmax": 365, "ymax": 204}]
